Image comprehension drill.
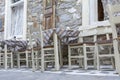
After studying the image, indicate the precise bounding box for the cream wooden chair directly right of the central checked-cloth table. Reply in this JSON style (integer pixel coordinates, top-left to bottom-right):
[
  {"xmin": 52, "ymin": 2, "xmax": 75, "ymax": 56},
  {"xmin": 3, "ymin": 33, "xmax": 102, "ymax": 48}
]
[{"xmin": 68, "ymin": 30, "xmax": 96, "ymax": 69}]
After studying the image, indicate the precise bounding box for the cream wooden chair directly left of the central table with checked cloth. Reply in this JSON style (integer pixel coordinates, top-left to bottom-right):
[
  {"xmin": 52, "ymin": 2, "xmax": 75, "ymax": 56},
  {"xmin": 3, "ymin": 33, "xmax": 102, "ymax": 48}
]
[{"xmin": 29, "ymin": 24, "xmax": 59, "ymax": 71}]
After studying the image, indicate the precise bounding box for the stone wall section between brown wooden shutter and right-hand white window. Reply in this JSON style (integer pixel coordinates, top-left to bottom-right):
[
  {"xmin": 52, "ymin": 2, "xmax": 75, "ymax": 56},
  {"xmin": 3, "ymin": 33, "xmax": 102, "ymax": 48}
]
[{"xmin": 56, "ymin": 0, "xmax": 82, "ymax": 28}]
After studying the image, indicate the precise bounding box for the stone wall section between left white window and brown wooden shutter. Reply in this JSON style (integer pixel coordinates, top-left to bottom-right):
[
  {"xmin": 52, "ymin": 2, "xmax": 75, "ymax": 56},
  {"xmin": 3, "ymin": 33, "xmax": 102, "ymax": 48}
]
[{"xmin": 27, "ymin": 0, "xmax": 43, "ymax": 27}]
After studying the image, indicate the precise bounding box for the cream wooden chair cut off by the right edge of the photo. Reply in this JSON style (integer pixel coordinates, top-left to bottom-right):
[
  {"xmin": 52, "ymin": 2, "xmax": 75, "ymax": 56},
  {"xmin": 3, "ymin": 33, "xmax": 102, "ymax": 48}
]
[{"xmin": 106, "ymin": 4, "xmax": 120, "ymax": 74}]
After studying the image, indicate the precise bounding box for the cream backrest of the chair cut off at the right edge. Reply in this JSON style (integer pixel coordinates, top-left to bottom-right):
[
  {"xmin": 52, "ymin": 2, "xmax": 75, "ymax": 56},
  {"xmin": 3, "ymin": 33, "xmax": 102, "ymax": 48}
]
[{"xmin": 107, "ymin": 4, "xmax": 120, "ymax": 39}]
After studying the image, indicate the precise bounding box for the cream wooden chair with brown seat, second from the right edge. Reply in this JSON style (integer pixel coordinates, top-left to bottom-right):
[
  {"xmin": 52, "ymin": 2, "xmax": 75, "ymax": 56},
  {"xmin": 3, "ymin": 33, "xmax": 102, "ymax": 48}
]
[{"xmin": 96, "ymin": 31, "xmax": 114, "ymax": 70}]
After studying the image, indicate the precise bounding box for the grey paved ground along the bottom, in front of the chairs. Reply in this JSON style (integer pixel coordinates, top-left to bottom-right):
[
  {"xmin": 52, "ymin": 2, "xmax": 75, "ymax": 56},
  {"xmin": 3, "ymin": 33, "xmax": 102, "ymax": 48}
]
[{"xmin": 0, "ymin": 70, "xmax": 120, "ymax": 80}]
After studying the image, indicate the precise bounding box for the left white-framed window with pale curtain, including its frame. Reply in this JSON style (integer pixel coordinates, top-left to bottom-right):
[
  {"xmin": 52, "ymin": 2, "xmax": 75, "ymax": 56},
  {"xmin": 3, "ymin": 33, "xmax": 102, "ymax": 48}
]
[{"xmin": 4, "ymin": 0, "xmax": 27, "ymax": 40}]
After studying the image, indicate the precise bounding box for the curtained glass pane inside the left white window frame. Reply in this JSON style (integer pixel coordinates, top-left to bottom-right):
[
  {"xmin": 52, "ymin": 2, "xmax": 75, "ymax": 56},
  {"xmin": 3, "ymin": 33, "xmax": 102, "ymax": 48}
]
[{"xmin": 10, "ymin": 5, "xmax": 23, "ymax": 37}]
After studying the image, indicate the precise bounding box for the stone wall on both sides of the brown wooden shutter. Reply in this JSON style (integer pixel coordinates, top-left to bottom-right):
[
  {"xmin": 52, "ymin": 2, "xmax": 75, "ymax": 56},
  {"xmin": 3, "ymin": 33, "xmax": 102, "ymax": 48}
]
[{"xmin": 28, "ymin": 0, "xmax": 81, "ymax": 28}]
